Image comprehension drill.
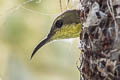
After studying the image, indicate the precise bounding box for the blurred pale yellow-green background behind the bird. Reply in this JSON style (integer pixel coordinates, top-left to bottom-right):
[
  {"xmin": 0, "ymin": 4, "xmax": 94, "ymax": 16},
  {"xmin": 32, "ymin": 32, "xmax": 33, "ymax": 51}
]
[{"xmin": 0, "ymin": 0, "xmax": 80, "ymax": 80}]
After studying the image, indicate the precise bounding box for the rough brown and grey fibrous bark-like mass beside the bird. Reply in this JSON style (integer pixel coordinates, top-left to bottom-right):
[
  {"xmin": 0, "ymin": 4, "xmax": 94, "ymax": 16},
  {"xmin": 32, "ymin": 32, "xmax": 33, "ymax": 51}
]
[{"xmin": 79, "ymin": 0, "xmax": 120, "ymax": 80}]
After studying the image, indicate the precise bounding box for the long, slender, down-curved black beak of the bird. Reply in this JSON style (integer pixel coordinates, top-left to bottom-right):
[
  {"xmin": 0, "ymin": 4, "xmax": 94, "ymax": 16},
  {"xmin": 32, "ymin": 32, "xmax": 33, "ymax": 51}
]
[{"xmin": 30, "ymin": 37, "xmax": 50, "ymax": 59}]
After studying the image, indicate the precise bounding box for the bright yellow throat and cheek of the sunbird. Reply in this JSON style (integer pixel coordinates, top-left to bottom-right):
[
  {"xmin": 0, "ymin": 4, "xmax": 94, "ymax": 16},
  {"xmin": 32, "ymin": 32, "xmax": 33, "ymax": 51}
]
[{"xmin": 51, "ymin": 23, "xmax": 82, "ymax": 40}]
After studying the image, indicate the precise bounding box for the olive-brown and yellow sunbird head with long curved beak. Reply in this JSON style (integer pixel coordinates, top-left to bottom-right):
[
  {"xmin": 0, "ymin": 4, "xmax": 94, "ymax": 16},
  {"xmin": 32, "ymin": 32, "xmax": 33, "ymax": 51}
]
[{"xmin": 31, "ymin": 10, "xmax": 82, "ymax": 59}]
